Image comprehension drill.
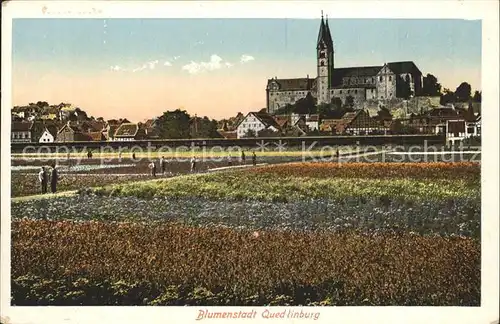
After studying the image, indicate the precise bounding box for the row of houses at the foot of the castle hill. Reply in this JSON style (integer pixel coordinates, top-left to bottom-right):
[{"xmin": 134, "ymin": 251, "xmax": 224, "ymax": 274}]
[{"xmin": 224, "ymin": 106, "xmax": 481, "ymax": 140}]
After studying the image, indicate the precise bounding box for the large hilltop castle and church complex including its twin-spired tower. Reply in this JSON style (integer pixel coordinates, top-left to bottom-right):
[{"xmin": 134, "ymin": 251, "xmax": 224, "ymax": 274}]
[{"xmin": 266, "ymin": 14, "xmax": 422, "ymax": 114}]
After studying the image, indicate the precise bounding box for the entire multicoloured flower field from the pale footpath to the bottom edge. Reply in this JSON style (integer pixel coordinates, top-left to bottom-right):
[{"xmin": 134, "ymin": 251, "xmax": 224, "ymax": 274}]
[{"xmin": 11, "ymin": 162, "xmax": 481, "ymax": 306}]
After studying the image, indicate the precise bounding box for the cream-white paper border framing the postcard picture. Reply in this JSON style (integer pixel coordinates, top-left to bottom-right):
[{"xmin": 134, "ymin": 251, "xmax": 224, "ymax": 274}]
[{"xmin": 0, "ymin": 0, "xmax": 499, "ymax": 324}]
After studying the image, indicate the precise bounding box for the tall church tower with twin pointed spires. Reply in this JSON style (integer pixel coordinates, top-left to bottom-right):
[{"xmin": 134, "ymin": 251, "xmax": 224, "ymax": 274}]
[{"xmin": 316, "ymin": 12, "xmax": 334, "ymax": 104}]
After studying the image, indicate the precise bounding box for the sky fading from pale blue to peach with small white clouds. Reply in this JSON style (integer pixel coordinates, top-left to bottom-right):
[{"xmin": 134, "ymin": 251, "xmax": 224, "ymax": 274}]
[{"xmin": 12, "ymin": 18, "xmax": 481, "ymax": 121}]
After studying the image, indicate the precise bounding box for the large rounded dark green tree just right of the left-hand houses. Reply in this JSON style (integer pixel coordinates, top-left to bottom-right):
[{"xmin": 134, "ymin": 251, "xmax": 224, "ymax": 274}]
[{"xmin": 157, "ymin": 109, "xmax": 191, "ymax": 139}]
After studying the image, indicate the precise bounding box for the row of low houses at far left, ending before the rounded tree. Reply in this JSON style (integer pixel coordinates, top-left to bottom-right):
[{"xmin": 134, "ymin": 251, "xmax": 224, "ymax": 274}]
[{"xmin": 11, "ymin": 119, "xmax": 159, "ymax": 143}]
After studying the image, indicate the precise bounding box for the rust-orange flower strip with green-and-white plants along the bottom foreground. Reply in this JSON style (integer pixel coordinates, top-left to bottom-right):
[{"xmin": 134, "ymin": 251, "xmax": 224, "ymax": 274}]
[{"xmin": 12, "ymin": 220, "xmax": 481, "ymax": 305}]
